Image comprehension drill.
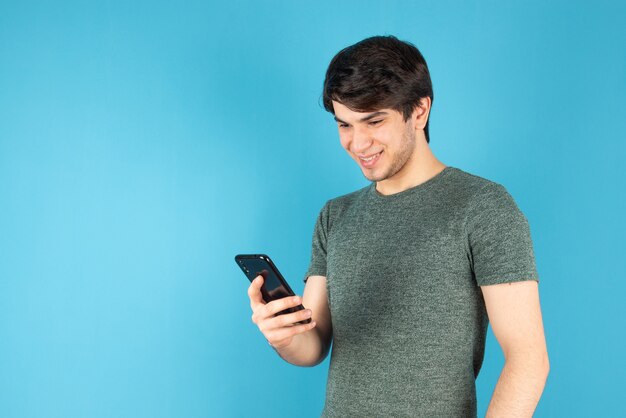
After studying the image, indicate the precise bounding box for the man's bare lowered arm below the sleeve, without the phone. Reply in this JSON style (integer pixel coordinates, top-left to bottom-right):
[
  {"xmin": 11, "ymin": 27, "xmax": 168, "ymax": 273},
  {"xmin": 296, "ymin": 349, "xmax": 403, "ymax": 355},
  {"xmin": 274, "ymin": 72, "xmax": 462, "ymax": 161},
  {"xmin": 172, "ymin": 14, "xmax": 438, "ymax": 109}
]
[{"xmin": 481, "ymin": 280, "xmax": 550, "ymax": 418}]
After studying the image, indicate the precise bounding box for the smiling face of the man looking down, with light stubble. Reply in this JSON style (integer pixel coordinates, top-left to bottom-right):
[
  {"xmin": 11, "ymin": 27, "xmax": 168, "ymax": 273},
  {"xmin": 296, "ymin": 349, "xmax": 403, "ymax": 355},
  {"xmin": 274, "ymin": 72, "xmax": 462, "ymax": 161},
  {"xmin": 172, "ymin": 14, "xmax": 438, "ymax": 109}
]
[{"xmin": 333, "ymin": 101, "xmax": 415, "ymax": 182}]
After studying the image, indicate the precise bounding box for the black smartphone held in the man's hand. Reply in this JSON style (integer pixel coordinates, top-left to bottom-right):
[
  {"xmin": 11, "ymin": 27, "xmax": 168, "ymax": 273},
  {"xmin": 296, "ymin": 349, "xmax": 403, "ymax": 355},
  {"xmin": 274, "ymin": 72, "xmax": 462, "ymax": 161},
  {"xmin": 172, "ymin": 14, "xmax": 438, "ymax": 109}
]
[{"xmin": 235, "ymin": 254, "xmax": 311, "ymax": 324}]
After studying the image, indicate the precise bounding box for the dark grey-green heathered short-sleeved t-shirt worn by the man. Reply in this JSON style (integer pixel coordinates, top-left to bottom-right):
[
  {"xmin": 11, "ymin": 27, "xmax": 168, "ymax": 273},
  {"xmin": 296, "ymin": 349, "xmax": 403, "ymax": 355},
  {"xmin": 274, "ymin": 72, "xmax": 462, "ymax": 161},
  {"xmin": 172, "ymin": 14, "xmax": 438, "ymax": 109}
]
[{"xmin": 304, "ymin": 167, "xmax": 538, "ymax": 417}]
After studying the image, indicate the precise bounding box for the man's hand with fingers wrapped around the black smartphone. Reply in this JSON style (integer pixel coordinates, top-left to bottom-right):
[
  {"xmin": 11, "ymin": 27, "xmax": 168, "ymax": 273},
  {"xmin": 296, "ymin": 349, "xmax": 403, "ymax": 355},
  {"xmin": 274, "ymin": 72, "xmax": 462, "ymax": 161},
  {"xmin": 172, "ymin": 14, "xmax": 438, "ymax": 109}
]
[{"xmin": 248, "ymin": 275, "xmax": 315, "ymax": 349}]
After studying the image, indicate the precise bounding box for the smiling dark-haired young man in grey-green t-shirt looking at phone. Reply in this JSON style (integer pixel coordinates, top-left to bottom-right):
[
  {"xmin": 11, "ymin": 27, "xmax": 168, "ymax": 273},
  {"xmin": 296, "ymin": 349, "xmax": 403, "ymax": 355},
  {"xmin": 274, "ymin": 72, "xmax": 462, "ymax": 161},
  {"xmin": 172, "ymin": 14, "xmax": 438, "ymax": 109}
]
[{"xmin": 248, "ymin": 36, "xmax": 549, "ymax": 417}]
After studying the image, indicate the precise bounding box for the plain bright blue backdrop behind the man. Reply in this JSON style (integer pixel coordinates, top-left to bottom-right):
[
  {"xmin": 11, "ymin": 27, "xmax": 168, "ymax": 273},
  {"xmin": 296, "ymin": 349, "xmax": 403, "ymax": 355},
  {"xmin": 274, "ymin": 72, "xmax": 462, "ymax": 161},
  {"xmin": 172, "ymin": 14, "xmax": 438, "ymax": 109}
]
[{"xmin": 0, "ymin": 0, "xmax": 626, "ymax": 417}]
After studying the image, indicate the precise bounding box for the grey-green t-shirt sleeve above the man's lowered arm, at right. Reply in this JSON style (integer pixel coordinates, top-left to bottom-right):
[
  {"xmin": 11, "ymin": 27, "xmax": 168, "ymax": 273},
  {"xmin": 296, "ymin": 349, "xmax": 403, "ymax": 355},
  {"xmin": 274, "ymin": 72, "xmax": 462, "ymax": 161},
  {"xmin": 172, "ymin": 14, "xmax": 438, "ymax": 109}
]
[{"xmin": 466, "ymin": 183, "xmax": 539, "ymax": 286}]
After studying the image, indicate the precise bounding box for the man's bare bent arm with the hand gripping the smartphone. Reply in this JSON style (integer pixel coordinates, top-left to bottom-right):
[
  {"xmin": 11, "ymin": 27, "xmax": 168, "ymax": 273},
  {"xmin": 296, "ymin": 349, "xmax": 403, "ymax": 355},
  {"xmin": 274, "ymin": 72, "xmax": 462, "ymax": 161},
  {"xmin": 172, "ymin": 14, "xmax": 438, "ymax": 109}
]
[{"xmin": 248, "ymin": 276, "xmax": 332, "ymax": 366}]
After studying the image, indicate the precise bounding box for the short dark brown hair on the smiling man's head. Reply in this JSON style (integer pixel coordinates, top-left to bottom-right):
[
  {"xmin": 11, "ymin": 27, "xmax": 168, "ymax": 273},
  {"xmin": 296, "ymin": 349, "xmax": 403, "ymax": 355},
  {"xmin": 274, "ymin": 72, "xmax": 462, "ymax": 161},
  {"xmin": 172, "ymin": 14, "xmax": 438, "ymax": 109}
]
[{"xmin": 323, "ymin": 35, "xmax": 433, "ymax": 142}]
